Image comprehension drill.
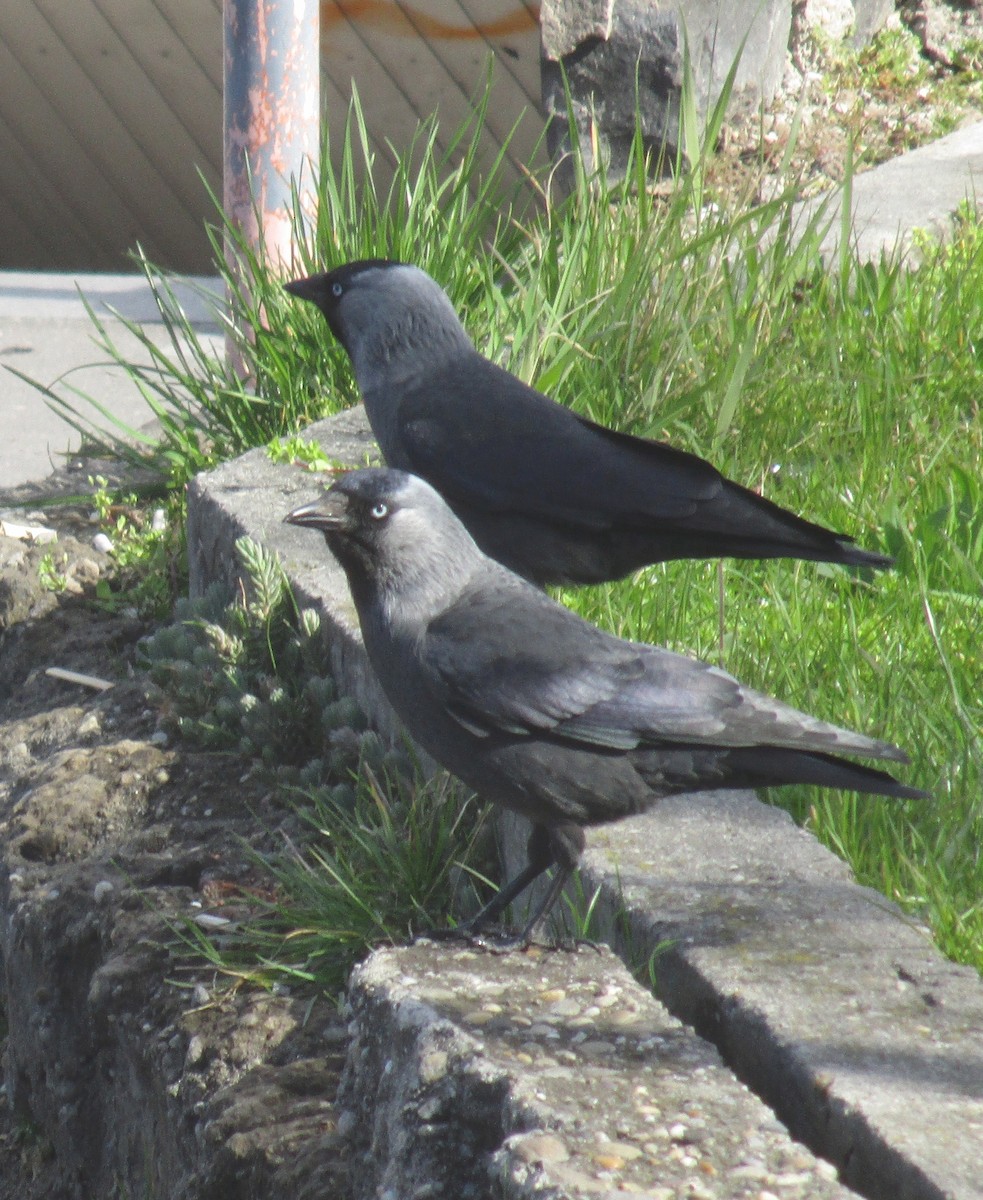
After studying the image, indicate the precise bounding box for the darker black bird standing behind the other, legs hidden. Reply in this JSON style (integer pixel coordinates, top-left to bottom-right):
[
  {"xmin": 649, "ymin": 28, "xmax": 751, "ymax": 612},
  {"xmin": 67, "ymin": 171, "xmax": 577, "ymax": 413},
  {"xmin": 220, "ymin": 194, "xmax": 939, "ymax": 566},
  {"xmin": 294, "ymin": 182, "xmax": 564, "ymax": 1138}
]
[{"xmin": 284, "ymin": 259, "xmax": 892, "ymax": 587}]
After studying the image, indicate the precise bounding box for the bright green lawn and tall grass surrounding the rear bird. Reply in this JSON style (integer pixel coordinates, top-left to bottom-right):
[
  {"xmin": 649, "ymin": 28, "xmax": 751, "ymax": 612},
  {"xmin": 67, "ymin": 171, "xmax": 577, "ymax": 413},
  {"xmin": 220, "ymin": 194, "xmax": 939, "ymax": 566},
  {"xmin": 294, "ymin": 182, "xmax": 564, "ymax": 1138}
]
[{"xmin": 32, "ymin": 72, "xmax": 983, "ymax": 968}]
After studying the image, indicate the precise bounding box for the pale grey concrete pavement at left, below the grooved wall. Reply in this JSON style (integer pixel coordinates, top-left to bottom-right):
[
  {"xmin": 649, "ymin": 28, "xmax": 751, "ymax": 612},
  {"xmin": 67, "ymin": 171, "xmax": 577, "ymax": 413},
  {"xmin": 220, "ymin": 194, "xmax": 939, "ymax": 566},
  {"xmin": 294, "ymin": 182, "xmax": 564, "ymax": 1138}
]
[{"xmin": 0, "ymin": 271, "xmax": 223, "ymax": 492}]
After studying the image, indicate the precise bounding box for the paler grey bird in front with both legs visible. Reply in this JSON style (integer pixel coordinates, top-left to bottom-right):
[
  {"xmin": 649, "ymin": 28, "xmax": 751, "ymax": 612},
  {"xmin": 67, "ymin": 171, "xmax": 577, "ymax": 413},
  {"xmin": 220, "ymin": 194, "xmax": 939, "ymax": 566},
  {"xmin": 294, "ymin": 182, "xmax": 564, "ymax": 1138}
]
[{"xmin": 284, "ymin": 468, "xmax": 927, "ymax": 944}]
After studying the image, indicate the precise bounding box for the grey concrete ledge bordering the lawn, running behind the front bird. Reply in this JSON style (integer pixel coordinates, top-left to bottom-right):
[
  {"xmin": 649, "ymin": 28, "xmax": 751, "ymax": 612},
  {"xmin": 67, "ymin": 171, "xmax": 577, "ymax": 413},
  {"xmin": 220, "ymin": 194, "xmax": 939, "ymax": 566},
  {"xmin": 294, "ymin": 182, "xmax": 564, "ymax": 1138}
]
[{"xmin": 188, "ymin": 413, "xmax": 983, "ymax": 1200}]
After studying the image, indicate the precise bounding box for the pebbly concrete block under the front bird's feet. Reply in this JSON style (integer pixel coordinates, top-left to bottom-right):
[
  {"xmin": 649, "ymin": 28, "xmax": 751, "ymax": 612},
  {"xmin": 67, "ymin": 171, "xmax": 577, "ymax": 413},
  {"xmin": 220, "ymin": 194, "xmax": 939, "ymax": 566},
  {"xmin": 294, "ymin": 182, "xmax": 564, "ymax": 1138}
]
[{"xmin": 337, "ymin": 942, "xmax": 855, "ymax": 1200}]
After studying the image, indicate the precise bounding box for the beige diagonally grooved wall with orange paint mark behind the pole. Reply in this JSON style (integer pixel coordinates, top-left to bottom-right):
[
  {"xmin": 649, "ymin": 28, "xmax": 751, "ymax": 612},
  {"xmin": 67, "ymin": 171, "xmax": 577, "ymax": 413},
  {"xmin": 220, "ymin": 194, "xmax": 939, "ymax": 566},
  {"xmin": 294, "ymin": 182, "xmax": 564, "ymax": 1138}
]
[{"xmin": 0, "ymin": 0, "xmax": 541, "ymax": 271}]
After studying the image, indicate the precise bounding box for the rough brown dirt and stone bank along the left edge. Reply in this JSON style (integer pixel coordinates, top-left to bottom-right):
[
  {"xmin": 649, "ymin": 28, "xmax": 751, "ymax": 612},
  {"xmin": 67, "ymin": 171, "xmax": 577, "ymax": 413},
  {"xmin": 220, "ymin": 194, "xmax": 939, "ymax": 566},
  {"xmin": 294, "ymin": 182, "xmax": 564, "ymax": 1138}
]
[{"xmin": 0, "ymin": 482, "xmax": 346, "ymax": 1200}]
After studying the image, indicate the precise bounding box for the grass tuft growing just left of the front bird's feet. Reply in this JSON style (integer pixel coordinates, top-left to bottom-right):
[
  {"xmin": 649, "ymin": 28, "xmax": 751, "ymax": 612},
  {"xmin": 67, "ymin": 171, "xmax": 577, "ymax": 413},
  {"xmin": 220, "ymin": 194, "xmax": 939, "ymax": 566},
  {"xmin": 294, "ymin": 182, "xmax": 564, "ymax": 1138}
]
[{"xmin": 175, "ymin": 766, "xmax": 491, "ymax": 995}]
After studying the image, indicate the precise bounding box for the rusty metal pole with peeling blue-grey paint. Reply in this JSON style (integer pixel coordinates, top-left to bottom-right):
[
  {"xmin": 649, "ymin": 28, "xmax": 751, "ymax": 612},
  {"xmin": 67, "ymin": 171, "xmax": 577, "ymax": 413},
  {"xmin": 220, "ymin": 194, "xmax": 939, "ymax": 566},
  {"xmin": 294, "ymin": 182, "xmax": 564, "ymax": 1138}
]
[{"xmin": 223, "ymin": 0, "xmax": 320, "ymax": 304}]
